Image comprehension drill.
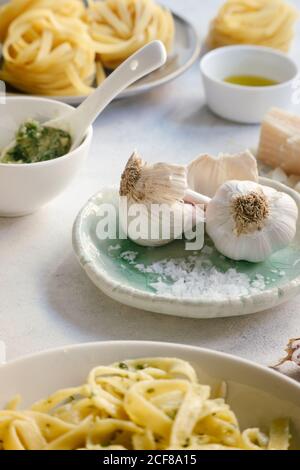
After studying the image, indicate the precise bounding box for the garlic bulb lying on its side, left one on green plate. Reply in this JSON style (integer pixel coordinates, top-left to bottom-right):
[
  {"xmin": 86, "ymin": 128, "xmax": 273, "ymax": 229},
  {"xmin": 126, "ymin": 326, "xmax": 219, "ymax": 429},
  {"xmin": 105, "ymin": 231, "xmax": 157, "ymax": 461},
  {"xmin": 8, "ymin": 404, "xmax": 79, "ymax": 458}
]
[{"xmin": 119, "ymin": 152, "xmax": 204, "ymax": 249}]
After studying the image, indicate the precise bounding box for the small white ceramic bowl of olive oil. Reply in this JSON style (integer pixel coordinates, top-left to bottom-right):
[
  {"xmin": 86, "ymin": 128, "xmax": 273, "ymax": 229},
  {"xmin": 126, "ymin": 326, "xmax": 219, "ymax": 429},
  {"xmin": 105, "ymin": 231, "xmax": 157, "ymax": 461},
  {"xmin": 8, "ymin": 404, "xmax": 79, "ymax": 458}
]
[{"xmin": 200, "ymin": 46, "xmax": 298, "ymax": 124}]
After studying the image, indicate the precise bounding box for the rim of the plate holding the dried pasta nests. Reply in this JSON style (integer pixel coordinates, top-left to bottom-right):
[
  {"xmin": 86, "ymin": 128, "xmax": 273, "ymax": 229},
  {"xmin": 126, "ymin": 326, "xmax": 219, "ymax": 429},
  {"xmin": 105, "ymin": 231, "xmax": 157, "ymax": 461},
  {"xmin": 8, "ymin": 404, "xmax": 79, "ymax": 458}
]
[{"xmin": 0, "ymin": 10, "xmax": 201, "ymax": 104}]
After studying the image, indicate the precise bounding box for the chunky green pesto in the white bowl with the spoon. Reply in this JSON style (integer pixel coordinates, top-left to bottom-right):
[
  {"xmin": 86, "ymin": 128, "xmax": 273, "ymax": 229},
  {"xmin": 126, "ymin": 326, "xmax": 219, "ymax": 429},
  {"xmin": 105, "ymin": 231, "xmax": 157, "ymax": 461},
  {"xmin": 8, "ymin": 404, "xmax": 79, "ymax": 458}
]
[{"xmin": 1, "ymin": 121, "xmax": 72, "ymax": 163}]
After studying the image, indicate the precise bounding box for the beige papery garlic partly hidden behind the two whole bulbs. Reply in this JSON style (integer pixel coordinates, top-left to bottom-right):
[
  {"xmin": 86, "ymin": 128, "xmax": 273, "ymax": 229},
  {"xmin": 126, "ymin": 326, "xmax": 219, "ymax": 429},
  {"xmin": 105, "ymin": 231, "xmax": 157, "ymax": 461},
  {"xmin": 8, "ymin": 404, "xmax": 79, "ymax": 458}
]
[{"xmin": 187, "ymin": 150, "xmax": 258, "ymax": 197}]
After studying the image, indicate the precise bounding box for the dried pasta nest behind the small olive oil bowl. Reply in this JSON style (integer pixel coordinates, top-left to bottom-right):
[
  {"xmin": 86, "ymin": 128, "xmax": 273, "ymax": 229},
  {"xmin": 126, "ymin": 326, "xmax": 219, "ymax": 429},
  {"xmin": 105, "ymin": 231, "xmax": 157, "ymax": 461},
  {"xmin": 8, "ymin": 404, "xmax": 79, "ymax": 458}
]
[{"xmin": 208, "ymin": 0, "xmax": 299, "ymax": 52}]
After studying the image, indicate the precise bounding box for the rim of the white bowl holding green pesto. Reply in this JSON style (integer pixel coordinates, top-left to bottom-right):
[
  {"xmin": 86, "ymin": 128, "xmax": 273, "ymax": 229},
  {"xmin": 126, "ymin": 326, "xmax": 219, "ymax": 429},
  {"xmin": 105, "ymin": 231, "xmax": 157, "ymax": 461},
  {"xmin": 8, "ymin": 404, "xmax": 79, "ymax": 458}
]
[{"xmin": 0, "ymin": 95, "xmax": 93, "ymax": 169}]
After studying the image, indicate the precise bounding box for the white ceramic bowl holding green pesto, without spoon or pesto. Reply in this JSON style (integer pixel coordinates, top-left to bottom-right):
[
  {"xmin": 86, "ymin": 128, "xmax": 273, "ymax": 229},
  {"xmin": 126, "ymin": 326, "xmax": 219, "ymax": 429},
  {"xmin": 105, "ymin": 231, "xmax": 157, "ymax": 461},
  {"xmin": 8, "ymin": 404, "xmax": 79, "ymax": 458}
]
[{"xmin": 0, "ymin": 97, "xmax": 93, "ymax": 217}]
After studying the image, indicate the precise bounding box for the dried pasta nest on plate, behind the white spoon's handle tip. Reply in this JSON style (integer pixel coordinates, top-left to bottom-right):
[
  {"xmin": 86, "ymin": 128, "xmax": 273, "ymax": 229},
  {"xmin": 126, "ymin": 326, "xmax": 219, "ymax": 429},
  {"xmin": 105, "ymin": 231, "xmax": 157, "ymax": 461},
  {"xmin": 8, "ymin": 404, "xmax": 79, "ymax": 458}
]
[{"xmin": 85, "ymin": 0, "xmax": 174, "ymax": 69}]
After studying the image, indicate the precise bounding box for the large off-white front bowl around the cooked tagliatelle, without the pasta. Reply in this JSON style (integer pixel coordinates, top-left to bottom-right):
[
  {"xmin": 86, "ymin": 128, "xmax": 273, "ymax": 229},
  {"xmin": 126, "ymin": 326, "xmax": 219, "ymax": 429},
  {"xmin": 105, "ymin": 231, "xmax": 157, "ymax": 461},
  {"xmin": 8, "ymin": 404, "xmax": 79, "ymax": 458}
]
[{"xmin": 0, "ymin": 341, "xmax": 300, "ymax": 448}]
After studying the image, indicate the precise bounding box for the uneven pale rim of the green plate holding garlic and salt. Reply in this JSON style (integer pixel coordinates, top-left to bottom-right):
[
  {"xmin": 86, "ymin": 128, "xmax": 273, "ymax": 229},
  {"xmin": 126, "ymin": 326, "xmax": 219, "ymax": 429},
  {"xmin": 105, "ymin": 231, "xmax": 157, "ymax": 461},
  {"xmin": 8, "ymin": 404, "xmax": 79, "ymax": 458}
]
[{"xmin": 73, "ymin": 178, "xmax": 300, "ymax": 319}]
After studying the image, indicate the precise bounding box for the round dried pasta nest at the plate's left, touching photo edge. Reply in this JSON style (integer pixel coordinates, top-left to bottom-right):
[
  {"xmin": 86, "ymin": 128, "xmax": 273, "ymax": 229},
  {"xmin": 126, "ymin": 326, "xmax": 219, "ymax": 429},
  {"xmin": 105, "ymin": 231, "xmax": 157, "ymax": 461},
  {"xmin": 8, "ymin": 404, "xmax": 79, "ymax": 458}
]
[{"xmin": 0, "ymin": 8, "xmax": 96, "ymax": 95}]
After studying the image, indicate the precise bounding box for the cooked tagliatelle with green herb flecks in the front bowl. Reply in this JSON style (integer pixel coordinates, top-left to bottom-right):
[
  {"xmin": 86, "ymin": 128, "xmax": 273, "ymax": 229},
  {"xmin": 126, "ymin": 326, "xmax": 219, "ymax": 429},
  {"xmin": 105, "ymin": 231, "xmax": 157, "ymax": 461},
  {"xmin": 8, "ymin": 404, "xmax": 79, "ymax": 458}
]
[{"xmin": 0, "ymin": 358, "xmax": 290, "ymax": 450}]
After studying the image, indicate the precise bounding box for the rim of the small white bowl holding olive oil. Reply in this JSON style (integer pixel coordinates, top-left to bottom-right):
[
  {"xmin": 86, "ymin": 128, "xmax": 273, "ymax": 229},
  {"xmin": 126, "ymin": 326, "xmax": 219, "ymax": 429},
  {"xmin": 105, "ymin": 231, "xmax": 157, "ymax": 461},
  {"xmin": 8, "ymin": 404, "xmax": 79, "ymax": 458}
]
[{"xmin": 200, "ymin": 45, "xmax": 299, "ymax": 91}]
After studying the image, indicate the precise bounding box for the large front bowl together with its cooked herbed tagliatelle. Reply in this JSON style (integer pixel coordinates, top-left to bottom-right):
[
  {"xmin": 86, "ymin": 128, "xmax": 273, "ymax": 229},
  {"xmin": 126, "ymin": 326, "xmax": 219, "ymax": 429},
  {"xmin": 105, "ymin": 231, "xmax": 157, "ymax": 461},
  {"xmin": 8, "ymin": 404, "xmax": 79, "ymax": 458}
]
[{"xmin": 0, "ymin": 341, "xmax": 300, "ymax": 450}]
